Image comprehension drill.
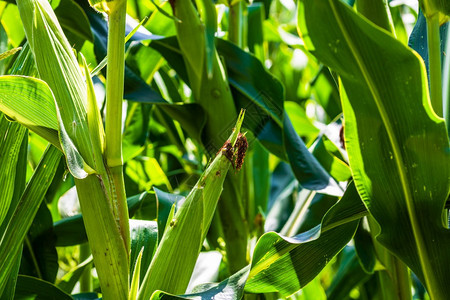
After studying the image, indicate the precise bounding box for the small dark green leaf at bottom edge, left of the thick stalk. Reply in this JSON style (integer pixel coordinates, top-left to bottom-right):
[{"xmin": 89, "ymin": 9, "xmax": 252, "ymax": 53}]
[{"xmin": 14, "ymin": 275, "xmax": 72, "ymax": 300}]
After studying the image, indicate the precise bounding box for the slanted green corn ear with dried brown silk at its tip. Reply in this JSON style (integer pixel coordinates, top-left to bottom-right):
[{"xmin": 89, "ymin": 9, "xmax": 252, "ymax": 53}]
[{"xmin": 138, "ymin": 112, "xmax": 248, "ymax": 300}]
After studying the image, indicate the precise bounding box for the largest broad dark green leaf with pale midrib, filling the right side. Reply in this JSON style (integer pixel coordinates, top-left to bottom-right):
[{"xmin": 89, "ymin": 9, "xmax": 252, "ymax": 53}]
[{"xmin": 299, "ymin": 0, "xmax": 450, "ymax": 299}]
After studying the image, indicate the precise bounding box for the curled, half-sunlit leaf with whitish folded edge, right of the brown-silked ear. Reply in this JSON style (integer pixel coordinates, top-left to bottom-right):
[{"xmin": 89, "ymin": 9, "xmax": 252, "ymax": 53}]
[{"xmin": 245, "ymin": 184, "xmax": 362, "ymax": 297}]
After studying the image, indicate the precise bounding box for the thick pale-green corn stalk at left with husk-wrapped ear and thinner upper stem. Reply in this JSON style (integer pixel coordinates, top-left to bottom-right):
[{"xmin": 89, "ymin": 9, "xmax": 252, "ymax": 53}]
[{"xmin": 17, "ymin": 0, "xmax": 130, "ymax": 299}]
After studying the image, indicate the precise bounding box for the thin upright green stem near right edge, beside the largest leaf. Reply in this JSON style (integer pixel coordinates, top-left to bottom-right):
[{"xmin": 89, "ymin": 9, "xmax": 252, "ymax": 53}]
[{"xmin": 427, "ymin": 14, "xmax": 443, "ymax": 117}]
